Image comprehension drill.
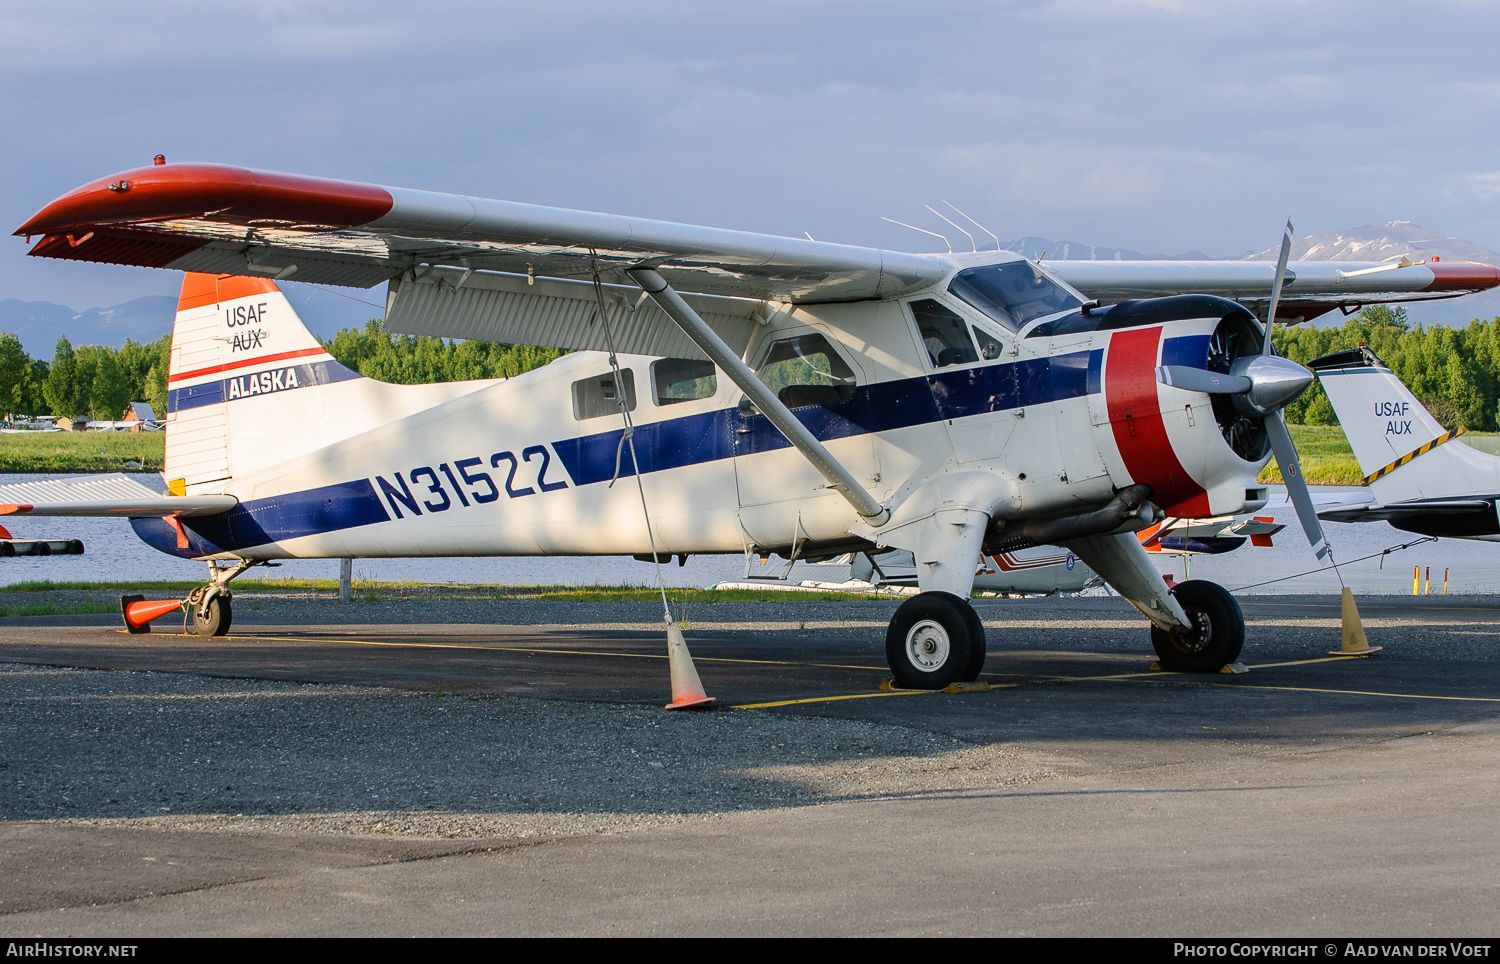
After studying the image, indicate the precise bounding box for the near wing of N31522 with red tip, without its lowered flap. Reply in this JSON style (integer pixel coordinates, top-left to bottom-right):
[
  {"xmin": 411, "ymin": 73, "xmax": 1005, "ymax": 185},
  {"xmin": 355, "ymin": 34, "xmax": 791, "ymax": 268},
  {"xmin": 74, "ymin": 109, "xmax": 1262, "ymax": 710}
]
[{"xmin": 15, "ymin": 163, "xmax": 948, "ymax": 301}]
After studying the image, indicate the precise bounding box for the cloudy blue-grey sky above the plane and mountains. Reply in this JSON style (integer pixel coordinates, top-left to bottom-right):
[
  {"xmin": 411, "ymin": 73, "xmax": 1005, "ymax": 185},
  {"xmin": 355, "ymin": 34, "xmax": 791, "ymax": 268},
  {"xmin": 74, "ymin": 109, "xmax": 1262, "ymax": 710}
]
[{"xmin": 0, "ymin": 0, "xmax": 1500, "ymax": 309}]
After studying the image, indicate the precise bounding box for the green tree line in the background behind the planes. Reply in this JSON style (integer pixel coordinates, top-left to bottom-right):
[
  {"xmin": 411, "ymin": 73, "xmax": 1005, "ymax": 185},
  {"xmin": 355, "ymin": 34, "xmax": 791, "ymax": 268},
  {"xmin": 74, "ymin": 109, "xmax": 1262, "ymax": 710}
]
[{"xmin": 0, "ymin": 306, "xmax": 1500, "ymax": 432}]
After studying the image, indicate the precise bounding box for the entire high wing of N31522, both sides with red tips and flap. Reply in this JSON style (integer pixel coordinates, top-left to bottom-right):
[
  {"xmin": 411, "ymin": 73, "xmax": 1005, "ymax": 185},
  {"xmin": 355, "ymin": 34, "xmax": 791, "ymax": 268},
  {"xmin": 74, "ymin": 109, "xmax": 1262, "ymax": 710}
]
[{"xmin": 15, "ymin": 162, "xmax": 1500, "ymax": 354}]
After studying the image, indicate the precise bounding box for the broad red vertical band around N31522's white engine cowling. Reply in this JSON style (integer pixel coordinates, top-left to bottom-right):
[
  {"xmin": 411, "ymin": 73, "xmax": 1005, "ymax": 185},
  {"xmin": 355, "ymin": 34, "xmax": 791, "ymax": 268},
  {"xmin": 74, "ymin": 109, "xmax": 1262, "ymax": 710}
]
[{"xmin": 1104, "ymin": 327, "xmax": 1209, "ymax": 519}]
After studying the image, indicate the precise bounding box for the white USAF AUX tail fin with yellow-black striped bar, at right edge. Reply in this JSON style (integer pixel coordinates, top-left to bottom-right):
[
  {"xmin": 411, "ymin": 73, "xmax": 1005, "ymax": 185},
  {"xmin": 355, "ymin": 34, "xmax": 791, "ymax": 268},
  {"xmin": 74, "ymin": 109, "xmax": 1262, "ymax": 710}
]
[{"xmin": 1308, "ymin": 348, "xmax": 1500, "ymax": 505}]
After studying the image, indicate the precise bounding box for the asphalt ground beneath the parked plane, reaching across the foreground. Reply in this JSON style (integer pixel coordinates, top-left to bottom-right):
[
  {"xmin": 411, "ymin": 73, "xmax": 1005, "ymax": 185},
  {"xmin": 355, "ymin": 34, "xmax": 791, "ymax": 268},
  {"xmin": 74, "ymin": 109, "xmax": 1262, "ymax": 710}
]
[{"xmin": 0, "ymin": 597, "xmax": 1500, "ymax": 937}]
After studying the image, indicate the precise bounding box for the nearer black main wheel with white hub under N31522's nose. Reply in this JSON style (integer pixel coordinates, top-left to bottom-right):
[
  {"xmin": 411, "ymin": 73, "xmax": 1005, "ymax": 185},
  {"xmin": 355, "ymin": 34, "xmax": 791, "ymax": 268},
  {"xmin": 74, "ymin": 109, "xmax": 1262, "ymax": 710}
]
[{"xmin": 885, "ymin": 592, "xmax": 984, "ymax": 690}]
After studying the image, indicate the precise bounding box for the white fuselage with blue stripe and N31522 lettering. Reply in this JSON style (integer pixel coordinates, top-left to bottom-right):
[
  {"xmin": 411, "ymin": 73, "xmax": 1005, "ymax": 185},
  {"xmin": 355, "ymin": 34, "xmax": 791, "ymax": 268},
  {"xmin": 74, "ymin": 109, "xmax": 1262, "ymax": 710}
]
[{"xmin": 135, "ymin": 269, "xmax": 1265, "ymax": 559}]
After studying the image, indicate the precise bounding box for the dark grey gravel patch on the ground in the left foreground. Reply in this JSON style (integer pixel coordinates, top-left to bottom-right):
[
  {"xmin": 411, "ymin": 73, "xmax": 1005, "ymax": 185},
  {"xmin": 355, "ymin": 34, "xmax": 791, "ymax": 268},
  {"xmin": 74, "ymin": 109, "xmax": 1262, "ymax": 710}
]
[{"xmin": 0, "ymin": 664, "xmax": 1058, "ymax": 838}]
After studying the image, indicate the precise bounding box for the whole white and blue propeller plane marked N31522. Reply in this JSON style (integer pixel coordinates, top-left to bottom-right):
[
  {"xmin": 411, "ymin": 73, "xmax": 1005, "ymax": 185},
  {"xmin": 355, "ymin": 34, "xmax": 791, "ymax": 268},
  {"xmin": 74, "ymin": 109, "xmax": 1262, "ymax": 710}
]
[{"xmin": 3, "ymin": 157, "xmax": 1500, "ymax": 688}]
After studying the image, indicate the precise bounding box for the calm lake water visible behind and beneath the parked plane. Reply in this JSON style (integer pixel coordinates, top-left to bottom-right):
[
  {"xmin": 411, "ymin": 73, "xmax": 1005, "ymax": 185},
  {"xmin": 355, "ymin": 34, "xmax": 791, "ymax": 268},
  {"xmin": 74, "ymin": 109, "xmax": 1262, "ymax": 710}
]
[{"xmin": 0, "ymin": 474, "xmax": 1500, "ymax": 594}]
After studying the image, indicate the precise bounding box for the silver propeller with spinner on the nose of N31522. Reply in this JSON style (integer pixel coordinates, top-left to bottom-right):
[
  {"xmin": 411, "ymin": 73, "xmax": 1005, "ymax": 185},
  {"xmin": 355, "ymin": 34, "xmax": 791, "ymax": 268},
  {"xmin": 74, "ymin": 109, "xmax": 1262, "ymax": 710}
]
[{"xmin": 1157, "ymin": 220, "xmax": 1331, "ymax": 562}]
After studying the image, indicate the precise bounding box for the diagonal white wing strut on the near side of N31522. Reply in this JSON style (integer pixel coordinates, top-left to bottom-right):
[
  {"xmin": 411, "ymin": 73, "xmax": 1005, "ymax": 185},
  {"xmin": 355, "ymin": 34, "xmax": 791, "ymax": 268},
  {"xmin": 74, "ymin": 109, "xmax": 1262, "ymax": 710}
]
[{"xmin": 627, "ymin": 268, "xmax": 891, "ymax": 526}]
